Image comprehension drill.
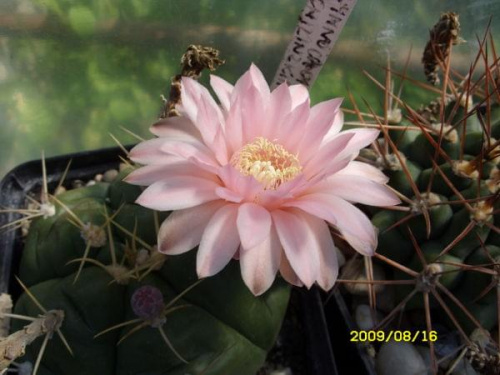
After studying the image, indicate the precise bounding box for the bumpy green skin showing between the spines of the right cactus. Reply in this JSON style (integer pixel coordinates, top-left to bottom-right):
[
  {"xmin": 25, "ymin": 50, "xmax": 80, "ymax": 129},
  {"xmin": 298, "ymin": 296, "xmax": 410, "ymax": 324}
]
[{"xmin": 372, "ymin": 101, "xmax": 500, "ymax": 333}]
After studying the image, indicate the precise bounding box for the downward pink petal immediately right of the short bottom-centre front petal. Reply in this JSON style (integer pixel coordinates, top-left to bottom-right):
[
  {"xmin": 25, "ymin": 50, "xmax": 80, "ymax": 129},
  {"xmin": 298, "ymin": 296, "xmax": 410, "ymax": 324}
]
[{"xmin": 271, "ymin": 210, "xmax": 320, "ymax": 288}]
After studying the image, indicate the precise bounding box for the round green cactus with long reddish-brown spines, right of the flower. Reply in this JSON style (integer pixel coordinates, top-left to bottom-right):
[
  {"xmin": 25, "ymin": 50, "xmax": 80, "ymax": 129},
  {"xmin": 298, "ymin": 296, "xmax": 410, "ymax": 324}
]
[{"xmin": 345, "ymin": 16, "xmax": 500, "ymax": 373}]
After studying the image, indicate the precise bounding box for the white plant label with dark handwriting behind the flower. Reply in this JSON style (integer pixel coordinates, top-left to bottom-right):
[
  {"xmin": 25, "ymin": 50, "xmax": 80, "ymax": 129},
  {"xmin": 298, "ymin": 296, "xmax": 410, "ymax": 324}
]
[{"xmin": 272, "ymin": 0, "xmax": 356, "ymax": 88}]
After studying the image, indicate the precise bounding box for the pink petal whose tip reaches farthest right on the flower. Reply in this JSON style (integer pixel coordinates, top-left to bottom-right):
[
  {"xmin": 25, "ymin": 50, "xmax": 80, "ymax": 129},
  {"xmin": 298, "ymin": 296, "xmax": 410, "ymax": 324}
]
[{"xmin": 310, "ymin": 174, "xmax": 401, "ymax": 207}]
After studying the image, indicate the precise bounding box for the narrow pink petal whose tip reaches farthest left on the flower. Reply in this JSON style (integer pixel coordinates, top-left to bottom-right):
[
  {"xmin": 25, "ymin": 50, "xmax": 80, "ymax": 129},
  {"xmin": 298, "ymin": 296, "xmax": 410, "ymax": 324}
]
[{"xmin": 123, "ymin": 161, "xmax": 217, "ymax": 186}]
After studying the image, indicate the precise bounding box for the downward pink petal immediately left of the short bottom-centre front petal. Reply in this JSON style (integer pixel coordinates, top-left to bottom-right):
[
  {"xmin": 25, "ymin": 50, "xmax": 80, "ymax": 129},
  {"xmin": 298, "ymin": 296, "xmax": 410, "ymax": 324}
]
[{"xmin": 196, "ymin": 204, "xmax": 240, "ymax": 278}]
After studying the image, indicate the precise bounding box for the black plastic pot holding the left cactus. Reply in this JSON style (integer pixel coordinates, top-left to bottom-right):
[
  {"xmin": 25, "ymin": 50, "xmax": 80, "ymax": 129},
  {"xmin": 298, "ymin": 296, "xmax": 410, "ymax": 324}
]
[{"xmin": 0, "ymin": 148, "xmax": 340, "ymax": 375}]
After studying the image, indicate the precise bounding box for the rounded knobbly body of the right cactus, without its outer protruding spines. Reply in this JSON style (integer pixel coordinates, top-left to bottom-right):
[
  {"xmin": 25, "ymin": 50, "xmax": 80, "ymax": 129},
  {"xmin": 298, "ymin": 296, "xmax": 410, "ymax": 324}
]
[{"xmin": 374, "ymin": 101, "xmax": 500, "ymax": 332}]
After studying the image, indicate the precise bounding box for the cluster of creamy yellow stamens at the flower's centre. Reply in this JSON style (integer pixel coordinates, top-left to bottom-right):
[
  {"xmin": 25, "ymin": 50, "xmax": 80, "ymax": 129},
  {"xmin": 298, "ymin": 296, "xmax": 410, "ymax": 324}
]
[{"xmin": 230, "ymin": 137, "xmax": 302, "ymax": 190}]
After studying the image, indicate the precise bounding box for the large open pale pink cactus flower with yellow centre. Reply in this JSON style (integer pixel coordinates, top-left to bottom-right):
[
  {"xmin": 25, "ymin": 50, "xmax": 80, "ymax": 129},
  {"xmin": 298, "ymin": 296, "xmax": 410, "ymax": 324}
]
[{"xmin": 127, "ymin": 65, "xmax": 400, "ymax": 295}]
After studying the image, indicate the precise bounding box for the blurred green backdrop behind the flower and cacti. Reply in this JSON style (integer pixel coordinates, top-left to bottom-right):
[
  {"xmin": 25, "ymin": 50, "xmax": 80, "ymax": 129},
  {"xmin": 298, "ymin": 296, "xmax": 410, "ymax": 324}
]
[{"xmin": 0, "ymin": 0, "xmax": 500, "ymax": 177}]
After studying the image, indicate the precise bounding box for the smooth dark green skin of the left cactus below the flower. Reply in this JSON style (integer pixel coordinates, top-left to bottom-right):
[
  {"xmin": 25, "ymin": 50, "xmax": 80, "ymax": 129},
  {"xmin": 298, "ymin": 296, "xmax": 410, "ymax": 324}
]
[{"xmin": 12, "ymin": 170, "xmax": 290, "ymax": 375}]
